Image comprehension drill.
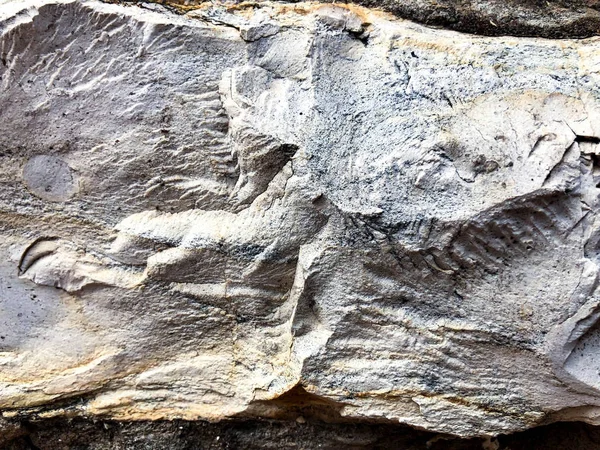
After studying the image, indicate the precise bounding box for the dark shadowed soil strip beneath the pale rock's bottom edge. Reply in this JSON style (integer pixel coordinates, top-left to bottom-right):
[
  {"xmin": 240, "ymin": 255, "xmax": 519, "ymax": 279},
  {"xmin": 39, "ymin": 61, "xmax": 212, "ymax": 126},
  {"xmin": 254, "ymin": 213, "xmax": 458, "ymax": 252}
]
[{"xmin": 0, "ymin": 419, "xmax": 600, "ymax": 450}]
